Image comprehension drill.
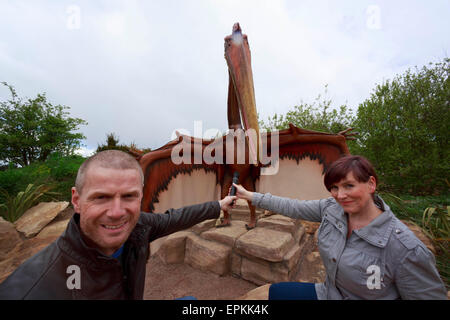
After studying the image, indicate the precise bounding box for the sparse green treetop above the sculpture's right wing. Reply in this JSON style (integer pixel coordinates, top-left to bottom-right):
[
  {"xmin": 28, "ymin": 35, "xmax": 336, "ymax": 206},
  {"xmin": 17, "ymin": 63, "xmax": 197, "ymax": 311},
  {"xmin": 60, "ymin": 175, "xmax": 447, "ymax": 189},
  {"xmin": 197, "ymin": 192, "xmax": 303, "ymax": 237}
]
[{"xmin": 259, "ymin": 86, "xmax": 354, "ymax": 133}]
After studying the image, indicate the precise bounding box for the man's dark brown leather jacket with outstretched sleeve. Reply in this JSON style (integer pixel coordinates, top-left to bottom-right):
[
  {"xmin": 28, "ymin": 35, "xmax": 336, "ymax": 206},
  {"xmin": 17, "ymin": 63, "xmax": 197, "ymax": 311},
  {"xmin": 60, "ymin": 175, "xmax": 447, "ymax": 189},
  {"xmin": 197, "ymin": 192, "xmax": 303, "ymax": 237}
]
[{"xmin": 0, "ymin": 201, "xmax": 220, "ymax": 300}]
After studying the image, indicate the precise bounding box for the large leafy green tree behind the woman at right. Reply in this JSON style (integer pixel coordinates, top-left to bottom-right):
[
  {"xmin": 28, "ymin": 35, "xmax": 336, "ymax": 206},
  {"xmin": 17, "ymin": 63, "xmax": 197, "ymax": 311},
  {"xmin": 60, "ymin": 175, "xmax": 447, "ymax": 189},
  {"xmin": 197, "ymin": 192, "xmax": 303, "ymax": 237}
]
[{"xmin": 355, "ymin": 58, "xmax": 450, "ymax": 194}]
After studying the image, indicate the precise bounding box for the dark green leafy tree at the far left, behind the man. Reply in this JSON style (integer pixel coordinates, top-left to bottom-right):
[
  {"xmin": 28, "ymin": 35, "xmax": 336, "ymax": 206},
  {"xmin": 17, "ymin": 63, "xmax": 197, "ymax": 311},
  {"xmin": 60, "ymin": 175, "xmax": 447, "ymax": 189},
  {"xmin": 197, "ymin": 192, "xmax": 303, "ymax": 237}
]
[{"xmin": 0, "ymin": 82, "xmax": 87, "ymax": 166}]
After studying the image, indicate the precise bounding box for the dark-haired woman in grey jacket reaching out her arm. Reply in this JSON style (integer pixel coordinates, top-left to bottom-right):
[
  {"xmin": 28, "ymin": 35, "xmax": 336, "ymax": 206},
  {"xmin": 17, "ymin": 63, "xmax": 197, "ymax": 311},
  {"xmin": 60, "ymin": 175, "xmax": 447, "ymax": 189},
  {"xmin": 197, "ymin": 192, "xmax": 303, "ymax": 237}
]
[{"xmin": 235, "ymin": 156, "xmax": 447, "ymax": 299}]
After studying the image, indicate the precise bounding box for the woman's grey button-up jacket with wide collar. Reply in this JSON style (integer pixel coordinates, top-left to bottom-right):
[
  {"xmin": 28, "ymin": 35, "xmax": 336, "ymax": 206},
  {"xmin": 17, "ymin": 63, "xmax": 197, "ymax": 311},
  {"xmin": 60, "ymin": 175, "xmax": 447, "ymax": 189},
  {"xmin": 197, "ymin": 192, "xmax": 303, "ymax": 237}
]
[{"xmin": 252, "ymin": 192, "xmax": 447, "ymax": 300}]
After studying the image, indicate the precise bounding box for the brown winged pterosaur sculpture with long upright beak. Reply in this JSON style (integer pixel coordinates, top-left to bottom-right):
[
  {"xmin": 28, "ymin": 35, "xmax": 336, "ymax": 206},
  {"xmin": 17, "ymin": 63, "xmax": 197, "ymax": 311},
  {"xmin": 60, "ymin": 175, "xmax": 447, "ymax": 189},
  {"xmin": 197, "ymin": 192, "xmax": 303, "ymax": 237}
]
[{"xmin": 136, "ymin": 23, "xmax": 354, "ymax": 229}]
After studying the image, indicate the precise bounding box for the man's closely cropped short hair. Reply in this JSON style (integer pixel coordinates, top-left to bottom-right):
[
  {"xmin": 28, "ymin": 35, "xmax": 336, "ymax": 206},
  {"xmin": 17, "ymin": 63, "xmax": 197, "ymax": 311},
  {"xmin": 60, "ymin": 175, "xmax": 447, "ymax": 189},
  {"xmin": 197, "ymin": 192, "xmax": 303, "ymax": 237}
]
[{"xmin": 75, "ymin": 150, "xmax": 144, "ymax": 193}]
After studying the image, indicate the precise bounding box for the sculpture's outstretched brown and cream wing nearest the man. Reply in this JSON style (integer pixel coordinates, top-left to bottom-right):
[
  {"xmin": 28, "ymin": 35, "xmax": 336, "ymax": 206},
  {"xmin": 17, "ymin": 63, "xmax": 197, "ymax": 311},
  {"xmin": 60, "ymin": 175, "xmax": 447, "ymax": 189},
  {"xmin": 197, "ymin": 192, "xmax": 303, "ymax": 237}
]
[{"xmin": 139, "ymin": 135, "xmax": 223, "ymax": 212}]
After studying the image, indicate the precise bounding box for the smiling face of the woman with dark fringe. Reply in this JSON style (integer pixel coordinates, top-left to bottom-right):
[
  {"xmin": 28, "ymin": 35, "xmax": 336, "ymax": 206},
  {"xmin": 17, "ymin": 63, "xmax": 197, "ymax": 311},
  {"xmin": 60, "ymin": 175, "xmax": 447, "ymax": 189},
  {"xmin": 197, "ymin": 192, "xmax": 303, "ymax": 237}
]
[{"xmin": 330, "ymin": 171, "xmax": 376, "ymax": 214}]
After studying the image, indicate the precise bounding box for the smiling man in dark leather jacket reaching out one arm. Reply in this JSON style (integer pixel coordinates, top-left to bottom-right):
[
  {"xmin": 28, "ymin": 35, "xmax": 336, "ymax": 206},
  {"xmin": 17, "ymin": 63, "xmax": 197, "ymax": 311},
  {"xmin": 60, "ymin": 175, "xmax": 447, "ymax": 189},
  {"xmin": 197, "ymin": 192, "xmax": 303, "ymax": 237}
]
[{"xmin": 0, "ymin": 150, "xmax": 236, "ymax": 299}]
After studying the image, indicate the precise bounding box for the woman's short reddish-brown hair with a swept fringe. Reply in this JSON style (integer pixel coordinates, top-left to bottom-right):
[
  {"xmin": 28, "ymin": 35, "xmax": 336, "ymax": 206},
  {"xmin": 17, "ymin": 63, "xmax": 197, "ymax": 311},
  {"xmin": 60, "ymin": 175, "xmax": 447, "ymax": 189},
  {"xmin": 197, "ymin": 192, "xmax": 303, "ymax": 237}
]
[{"xmin": 324, "ymin": 156, "xmax": 378, "ymax": 191}]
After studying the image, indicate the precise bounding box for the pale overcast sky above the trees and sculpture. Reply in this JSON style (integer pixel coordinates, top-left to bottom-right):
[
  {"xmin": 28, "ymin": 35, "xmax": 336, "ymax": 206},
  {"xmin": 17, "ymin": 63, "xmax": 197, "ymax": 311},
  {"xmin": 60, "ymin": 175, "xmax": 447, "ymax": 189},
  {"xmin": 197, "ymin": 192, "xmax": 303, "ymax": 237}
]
[{"xmin": 0, "ymin": 0, "xmax": 450, "ymax": 155}]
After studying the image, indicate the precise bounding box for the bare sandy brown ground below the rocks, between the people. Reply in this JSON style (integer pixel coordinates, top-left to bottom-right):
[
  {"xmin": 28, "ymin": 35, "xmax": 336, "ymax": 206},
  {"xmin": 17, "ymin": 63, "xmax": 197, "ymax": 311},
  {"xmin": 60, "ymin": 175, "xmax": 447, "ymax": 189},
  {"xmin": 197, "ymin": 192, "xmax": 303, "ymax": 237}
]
[{"xmin": 144, "ymin": 255, "xmax": 258, "ymax": 300}]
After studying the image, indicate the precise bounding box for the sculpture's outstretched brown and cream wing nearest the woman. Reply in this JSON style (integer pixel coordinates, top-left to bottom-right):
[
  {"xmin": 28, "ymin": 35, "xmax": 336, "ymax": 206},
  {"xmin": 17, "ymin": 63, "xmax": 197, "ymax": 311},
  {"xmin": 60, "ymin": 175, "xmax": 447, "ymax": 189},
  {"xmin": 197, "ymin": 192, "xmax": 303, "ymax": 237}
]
[{"xmin": 256, "ymin": 124, "xmax": 349, "ymax": 200}]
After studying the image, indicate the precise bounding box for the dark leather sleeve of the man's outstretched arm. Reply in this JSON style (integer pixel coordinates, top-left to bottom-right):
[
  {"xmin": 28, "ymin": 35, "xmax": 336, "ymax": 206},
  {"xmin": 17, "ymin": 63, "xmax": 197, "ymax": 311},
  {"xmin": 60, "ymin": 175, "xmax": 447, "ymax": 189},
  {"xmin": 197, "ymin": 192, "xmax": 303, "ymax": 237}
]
[{"xmin": 140, "ymin": 201, "xmax": 220, "ymax": 242}]
